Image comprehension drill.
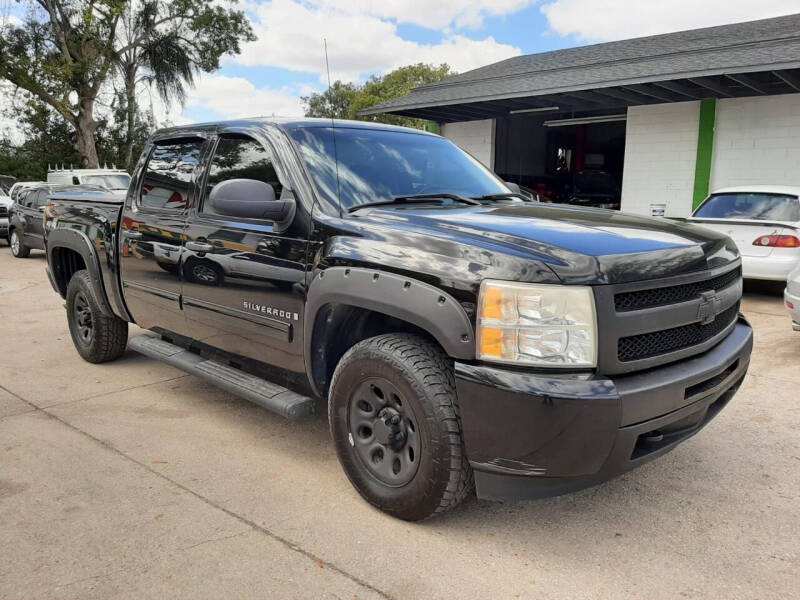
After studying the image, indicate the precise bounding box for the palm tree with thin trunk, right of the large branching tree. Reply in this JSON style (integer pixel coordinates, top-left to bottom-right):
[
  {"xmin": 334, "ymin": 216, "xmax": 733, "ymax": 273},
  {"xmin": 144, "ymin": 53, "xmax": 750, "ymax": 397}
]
[{"xmin": 116, "ymin": 0, "xmax": 255, "ymax": 169}]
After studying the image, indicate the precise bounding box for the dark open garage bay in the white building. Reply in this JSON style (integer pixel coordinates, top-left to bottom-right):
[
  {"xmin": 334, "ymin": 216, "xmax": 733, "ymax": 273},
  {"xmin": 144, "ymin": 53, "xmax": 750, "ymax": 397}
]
[{"xmin": 494, "ymin": 114, "xmax": 625, "ymax": 209}]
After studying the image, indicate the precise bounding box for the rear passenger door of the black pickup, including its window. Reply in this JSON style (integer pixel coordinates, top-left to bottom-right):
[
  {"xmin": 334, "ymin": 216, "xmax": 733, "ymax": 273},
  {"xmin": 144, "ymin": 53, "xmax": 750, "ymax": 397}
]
[{"xmin": 120, "ymin": 137, "xmax": 206, "ymax": 335}]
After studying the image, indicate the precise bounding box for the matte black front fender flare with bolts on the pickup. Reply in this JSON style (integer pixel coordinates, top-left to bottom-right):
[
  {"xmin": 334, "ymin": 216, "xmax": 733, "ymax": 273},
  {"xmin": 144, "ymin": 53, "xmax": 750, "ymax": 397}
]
[{"xmin": 303, "ymin": 267, "xmax": 475, "ymax": 394}]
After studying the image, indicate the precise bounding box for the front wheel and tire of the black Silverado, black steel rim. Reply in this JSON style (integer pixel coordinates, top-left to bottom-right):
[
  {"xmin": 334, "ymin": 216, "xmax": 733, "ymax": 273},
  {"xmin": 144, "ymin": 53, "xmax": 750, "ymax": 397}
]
[{"xmin": 328, "ymin": 334, "xmax": 473, "ymax": 521}]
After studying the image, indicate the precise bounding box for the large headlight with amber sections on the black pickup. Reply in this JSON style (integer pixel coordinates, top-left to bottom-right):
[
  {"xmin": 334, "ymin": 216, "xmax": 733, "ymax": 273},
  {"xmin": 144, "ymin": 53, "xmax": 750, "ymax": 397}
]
[{"xmin": 477, "ymin": 279, "xmax": 597, "ymax": 368}]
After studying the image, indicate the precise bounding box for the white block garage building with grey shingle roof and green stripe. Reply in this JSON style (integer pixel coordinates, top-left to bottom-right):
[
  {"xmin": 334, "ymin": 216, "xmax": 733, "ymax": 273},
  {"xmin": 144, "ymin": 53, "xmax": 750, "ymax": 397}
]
[{"xmin": 359, "ymin": 14, "xmax": 800, "ymax": 217}]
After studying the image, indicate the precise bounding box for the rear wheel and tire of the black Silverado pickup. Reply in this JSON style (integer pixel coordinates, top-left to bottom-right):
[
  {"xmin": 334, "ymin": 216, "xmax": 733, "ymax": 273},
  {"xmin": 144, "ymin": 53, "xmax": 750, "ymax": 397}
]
[{"xmin": 67, "ymin": 269, "xmax": 128, "ymax": 363}]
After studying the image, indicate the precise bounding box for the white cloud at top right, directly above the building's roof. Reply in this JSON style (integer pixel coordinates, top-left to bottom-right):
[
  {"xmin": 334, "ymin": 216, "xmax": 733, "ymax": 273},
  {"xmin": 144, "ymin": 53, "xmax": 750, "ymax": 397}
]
[{"xmin": 541, "ymin": 0, "xmax": 799, "ymax": 41}]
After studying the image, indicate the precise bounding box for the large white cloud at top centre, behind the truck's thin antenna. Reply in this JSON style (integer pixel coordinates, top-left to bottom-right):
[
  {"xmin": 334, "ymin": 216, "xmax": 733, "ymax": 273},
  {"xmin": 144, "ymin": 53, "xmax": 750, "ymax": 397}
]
[{"xmin": 234, "ymin": 0, "xmax": 522, "ymax": 81}]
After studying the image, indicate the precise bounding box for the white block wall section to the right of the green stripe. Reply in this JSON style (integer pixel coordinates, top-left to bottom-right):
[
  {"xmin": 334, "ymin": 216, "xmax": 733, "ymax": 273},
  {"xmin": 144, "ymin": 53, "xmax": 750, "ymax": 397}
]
[{"xmin": 711, "ymin": 94, "xmax": 800, "ymax": 190}]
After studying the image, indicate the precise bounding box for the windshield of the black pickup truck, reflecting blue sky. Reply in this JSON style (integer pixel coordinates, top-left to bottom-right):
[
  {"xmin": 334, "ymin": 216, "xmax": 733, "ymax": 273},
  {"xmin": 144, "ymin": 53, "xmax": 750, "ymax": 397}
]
[{"xmin": 289, "ymin": 127, "xmax": 510, "ymax": 210}]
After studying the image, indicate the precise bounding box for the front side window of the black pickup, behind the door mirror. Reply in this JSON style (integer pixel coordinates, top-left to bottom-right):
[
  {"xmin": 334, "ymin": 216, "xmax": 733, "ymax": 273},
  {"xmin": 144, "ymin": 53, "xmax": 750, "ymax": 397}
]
[{"xmin": 202, "ymin": 134, "xmax": 283, "ymax": 215}]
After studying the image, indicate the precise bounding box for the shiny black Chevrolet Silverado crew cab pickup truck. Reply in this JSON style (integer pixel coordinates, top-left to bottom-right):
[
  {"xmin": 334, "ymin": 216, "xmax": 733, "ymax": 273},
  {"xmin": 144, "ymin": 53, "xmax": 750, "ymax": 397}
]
[{"xmin": 45, "ymin": 119, "xmax": 752, "ymax": 520}]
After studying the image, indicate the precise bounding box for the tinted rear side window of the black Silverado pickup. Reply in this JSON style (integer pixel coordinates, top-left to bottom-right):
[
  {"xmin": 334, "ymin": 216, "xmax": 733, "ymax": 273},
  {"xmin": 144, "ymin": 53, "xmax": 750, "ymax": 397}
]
[{"xmin": 139, "ymin": 139, "xmax": 203, "ymax": 211}]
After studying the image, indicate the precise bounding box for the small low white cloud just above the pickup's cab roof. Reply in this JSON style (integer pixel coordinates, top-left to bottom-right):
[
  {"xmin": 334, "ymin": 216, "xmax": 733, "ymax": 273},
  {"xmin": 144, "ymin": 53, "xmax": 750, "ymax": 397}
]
[{"xmin": 179, "ymin": 75, "xmax": 303, "ymax": 121}]
